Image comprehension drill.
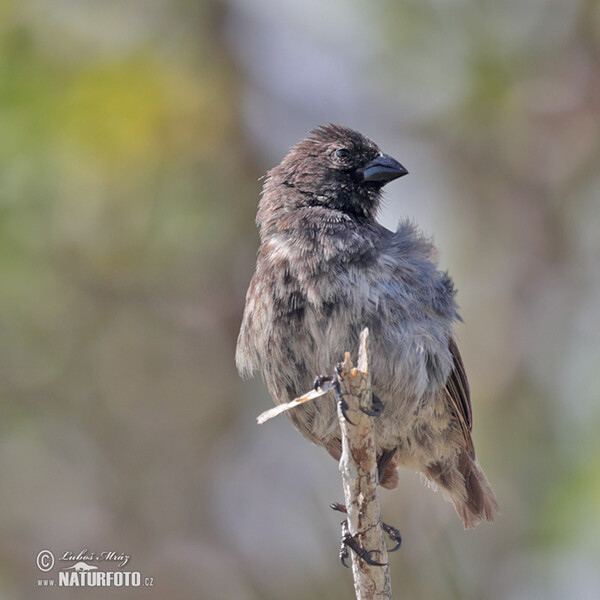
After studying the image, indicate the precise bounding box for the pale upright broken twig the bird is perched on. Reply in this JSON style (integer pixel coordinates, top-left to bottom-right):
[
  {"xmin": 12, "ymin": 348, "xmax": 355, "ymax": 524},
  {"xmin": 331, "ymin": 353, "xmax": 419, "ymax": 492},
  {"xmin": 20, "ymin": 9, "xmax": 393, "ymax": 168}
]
[{"xmin": 338, "ymin": 328, "xmax": 392, "ymax": 600}]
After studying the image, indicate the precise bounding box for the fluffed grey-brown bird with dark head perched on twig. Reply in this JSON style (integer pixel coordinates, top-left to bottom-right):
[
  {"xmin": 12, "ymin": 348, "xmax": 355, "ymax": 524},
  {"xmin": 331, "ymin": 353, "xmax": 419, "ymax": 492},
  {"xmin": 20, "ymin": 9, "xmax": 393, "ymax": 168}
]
[{"xmin": 236, "ymin": 124, "xmax": 499, "ymax": 529}]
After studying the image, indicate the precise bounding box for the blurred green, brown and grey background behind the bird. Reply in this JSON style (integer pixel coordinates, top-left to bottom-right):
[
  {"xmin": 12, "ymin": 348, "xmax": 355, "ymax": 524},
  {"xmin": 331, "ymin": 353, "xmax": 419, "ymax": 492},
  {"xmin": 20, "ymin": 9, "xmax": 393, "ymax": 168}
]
[{"xmin": 0, "ymin": 0, "xmax": 600, "ymax": 600}]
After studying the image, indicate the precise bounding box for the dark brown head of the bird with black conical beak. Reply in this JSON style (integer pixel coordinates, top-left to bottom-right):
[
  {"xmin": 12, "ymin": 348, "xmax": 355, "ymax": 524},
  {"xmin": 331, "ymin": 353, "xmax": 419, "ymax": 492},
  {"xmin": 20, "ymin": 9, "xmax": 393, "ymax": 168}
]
[{"xmin": 263, "ymin": 125, "xmax": 408, "ymax": 223}]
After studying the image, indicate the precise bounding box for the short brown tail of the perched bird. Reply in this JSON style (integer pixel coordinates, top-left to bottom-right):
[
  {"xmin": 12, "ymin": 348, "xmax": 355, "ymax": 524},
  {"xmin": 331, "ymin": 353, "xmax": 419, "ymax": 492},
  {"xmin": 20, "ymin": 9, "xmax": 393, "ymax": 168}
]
[{"xmin": 426, "ymin": 452, "xmax": 500, "ymax": 529}]
